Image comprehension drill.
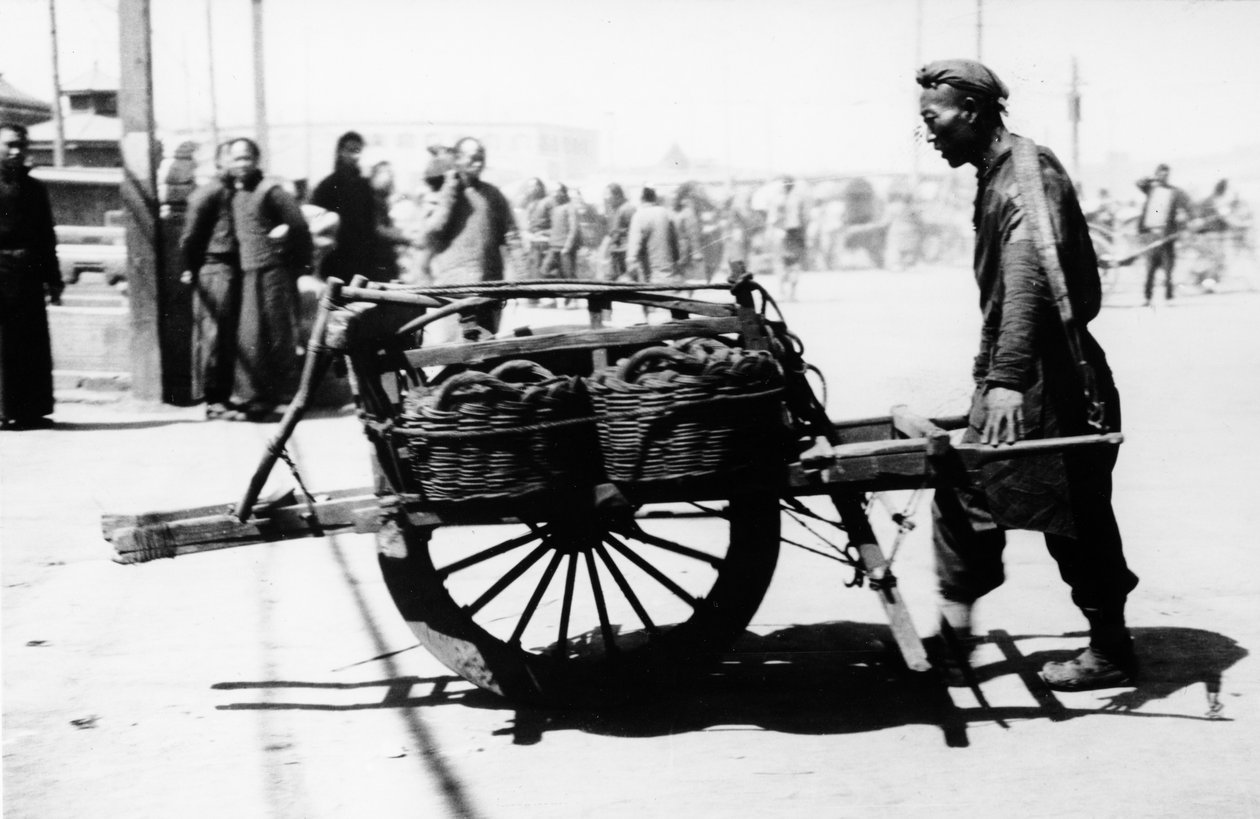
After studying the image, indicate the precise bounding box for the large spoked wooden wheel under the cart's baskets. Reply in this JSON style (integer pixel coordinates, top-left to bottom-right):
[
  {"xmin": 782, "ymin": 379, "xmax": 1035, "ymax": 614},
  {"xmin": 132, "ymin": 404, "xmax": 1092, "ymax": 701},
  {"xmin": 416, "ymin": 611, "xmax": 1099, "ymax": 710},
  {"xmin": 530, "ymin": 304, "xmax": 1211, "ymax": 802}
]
[{"xmin": 381, "ymin": 493, "xmax": 779, "ymax": 704}]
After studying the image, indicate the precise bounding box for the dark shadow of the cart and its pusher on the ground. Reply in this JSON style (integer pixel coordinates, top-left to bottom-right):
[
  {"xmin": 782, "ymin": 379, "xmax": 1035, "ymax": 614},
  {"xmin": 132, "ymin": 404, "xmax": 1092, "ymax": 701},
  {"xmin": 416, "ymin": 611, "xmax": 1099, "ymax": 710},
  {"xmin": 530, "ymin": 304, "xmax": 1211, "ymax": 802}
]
[{"xmin": 214, "ymin": 622, "xmax": 1247, "ymax": 747}]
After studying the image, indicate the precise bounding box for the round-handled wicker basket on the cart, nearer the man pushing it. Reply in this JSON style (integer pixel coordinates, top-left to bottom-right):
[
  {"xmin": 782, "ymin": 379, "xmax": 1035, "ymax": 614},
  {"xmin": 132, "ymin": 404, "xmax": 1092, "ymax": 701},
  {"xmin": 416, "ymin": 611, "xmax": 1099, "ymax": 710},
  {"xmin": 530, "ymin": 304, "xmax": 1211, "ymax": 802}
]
[{"xmin": 588, "ymin": 340, "xmax": 782, "ymax": 483}]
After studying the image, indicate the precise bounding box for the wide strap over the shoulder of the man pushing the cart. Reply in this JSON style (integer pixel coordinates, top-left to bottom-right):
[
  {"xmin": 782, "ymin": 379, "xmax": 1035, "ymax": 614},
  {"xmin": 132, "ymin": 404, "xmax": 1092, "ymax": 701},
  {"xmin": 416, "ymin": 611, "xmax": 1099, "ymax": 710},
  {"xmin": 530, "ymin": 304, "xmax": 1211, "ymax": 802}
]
[{"xmin": 1011, "ymin": 135, "xmax": 1105, "ymax": 430}]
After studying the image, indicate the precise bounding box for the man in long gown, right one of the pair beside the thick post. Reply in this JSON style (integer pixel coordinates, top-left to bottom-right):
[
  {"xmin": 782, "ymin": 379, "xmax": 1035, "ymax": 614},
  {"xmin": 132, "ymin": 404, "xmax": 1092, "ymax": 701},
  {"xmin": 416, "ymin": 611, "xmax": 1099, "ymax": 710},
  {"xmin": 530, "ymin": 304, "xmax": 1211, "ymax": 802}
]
[{"xmin": 227, "ymin": 137, "xmax": 312, "ymax": 421}]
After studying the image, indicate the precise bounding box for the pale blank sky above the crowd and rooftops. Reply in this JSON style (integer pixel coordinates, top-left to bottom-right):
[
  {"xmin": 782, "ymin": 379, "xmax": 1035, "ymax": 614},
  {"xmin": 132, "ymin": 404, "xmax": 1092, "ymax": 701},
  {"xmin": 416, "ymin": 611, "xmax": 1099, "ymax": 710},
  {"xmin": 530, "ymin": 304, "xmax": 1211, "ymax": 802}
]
[{"xmin": 0, "ymin": 0, "xmax": 1260, "ymax": 187}]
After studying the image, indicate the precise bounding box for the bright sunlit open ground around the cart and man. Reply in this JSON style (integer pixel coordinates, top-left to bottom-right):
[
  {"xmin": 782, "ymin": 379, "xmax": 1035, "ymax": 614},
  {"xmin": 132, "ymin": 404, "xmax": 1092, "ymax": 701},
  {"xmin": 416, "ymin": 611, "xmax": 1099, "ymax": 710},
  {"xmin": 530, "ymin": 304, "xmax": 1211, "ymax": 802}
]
[{"xmin": 0, "ymin": 264, "xmax": 1260, "ymax": 819}]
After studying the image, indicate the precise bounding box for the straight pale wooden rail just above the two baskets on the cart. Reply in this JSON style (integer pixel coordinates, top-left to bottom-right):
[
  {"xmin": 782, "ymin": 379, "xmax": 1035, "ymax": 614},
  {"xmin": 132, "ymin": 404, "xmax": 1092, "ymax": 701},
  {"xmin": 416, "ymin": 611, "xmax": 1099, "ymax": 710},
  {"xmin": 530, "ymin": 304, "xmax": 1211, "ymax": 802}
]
[{"xmin": 406, "ymin": 318, "xmax": 742, "ymax": 368}]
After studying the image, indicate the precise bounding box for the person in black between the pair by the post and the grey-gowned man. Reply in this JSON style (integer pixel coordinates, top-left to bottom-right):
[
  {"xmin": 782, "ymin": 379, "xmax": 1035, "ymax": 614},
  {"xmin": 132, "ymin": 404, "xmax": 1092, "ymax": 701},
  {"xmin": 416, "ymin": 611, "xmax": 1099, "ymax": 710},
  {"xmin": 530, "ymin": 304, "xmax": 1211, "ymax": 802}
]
[{"xmin": 310, "ymin": 131, "xmax": 382, "ymax": 281}]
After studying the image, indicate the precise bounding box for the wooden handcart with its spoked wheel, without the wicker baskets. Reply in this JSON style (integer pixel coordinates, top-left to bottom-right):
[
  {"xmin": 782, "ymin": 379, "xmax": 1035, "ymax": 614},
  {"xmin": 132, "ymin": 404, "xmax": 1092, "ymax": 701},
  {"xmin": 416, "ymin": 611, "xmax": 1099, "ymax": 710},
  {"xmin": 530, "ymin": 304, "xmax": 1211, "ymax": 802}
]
[{"xmin": 103, "ymin": 268, "xmax": 1121, "ymax": 703}]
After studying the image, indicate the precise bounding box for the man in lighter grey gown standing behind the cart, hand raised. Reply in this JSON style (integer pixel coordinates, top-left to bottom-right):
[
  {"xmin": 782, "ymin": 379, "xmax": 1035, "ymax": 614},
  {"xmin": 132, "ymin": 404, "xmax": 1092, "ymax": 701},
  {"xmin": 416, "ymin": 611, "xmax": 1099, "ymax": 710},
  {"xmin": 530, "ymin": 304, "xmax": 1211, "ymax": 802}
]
[{"xmin": 425, "ymin": 136, "xmax": 519, "ymax": 334}]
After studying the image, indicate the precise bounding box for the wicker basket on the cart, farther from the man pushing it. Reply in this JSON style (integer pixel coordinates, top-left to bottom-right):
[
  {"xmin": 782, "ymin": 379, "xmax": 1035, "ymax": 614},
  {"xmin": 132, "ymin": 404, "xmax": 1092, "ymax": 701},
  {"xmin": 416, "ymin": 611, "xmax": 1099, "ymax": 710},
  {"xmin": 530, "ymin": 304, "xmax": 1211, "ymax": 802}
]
[{"xmin": 396, "ymin": 362, "xmax": 599, "ymax": 503}]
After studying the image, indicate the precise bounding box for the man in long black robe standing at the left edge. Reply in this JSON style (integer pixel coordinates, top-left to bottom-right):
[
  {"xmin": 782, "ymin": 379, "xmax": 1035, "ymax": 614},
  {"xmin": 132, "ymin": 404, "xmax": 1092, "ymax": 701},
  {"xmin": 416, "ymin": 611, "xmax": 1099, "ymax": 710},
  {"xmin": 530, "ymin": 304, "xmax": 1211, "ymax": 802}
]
[{"xmin": 0, "ymin": 125, "xmax": 66, "ymax": 430}]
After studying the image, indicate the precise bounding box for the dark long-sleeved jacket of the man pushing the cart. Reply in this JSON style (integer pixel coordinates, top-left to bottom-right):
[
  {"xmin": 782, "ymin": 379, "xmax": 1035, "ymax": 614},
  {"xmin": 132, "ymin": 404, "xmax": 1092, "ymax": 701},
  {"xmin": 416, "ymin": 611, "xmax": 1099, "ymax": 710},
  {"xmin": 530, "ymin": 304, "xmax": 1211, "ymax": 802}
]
[{"xmin": 968, "ymin": 140, "xmax": 1120, "ymax": 536}]
